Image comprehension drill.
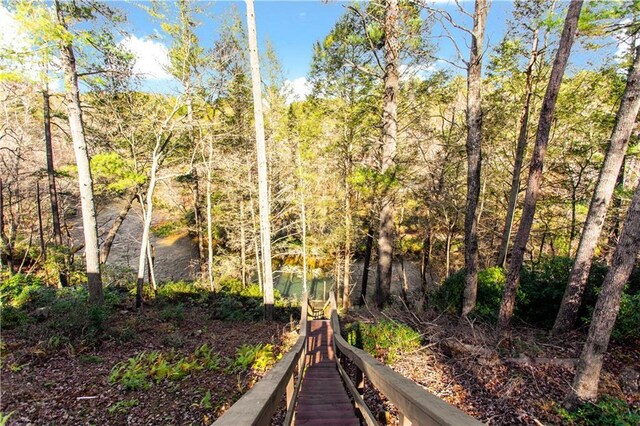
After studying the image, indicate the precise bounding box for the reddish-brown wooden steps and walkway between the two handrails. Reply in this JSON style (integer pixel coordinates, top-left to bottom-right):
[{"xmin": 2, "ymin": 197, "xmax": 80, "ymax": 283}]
[{"xmin": 294, "ymin": 320, "xmax": 360, "ymax": 426}]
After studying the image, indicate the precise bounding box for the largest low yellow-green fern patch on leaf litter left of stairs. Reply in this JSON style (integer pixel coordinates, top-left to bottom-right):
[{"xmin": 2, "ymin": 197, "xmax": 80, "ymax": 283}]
[{"xmin": 109, "ymin": 343, "xmax": 221, "ymax": 390}]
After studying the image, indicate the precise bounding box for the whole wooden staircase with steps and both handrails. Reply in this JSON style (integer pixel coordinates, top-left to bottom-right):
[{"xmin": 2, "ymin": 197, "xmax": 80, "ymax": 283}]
[{"xmin": 215, "ymin": 292, "xmax": 481, "ymax": 426}]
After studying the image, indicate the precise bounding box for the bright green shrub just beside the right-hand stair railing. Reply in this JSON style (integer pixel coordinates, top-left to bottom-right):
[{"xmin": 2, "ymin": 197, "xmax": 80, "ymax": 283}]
[{"xmin": 345, "ymin": 320, "xmax": 422, "ymax": 364}]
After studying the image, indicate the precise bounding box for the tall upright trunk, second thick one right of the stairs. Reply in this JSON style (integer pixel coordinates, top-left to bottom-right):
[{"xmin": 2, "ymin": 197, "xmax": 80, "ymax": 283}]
[{"xmin": 462, "ymin": 0, "xmax": 487, "ymax": 316}]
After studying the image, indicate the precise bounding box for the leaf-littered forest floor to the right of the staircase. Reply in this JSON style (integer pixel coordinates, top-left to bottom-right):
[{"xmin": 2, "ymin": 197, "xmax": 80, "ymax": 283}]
[{"xmin": 346, "ymin": 309, "xmax": 640, "ymax": 426}]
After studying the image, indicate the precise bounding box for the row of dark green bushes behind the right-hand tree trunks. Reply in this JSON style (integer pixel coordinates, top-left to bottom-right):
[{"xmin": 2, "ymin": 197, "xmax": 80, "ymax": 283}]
[{"xmin": 429, "ymin": 256, "xmax": 640, "ymax": 340}]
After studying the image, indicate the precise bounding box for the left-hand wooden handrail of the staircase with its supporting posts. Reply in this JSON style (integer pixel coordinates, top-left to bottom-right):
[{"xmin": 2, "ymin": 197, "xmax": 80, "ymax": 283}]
[{"xmin": 214, "ymin": 293, "xmax": 308, "ymax": 426}]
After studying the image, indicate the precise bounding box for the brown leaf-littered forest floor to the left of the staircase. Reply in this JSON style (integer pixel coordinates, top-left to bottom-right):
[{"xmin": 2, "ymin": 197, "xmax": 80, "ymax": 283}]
[{"xmin": 0, "ymin": 292, "xmax": 290, "ymax": 425}]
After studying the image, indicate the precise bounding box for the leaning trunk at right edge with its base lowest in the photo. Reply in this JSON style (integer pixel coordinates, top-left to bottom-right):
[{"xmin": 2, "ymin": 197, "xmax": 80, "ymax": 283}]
[{"xmin": 567, "ymin": 180, "xmax": 640, "ymax": 405}]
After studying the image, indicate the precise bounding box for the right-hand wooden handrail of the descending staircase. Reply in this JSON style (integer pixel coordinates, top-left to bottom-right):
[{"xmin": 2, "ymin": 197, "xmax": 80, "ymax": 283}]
[{"xmin": 329, "ymin": 291, "xmax": 482, "ymax": 426}]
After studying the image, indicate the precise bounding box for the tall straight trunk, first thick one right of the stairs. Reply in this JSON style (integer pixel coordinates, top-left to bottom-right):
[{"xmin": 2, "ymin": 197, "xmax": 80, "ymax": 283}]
[{"xmin": 376, "ymin": 0, "xmax": 399, "ymax": 308}]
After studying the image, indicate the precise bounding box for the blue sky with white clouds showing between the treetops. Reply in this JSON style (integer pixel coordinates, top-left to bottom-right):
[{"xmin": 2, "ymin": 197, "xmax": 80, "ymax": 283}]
[{"xmin": 0, "ymin": 0, "xmax": 616, "ymax": 95}]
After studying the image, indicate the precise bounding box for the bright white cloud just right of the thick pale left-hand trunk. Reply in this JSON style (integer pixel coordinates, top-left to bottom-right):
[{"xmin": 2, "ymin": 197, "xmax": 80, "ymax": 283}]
[{"xmin": 120, "ymin": 35, "xmax": 173, "ymax": 80}]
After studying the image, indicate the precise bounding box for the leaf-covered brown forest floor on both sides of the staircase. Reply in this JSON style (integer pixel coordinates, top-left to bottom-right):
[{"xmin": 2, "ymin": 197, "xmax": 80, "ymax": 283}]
[{"xmin": 0, "ymin": 287, "xmax": 640, "ymax": 425}]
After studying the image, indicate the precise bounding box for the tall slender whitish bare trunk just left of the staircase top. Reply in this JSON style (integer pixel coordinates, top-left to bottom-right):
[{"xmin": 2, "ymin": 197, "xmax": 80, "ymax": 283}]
[{"xmin": 246, "ymin": 0, "xmax": 273, "ymax": 321}]
